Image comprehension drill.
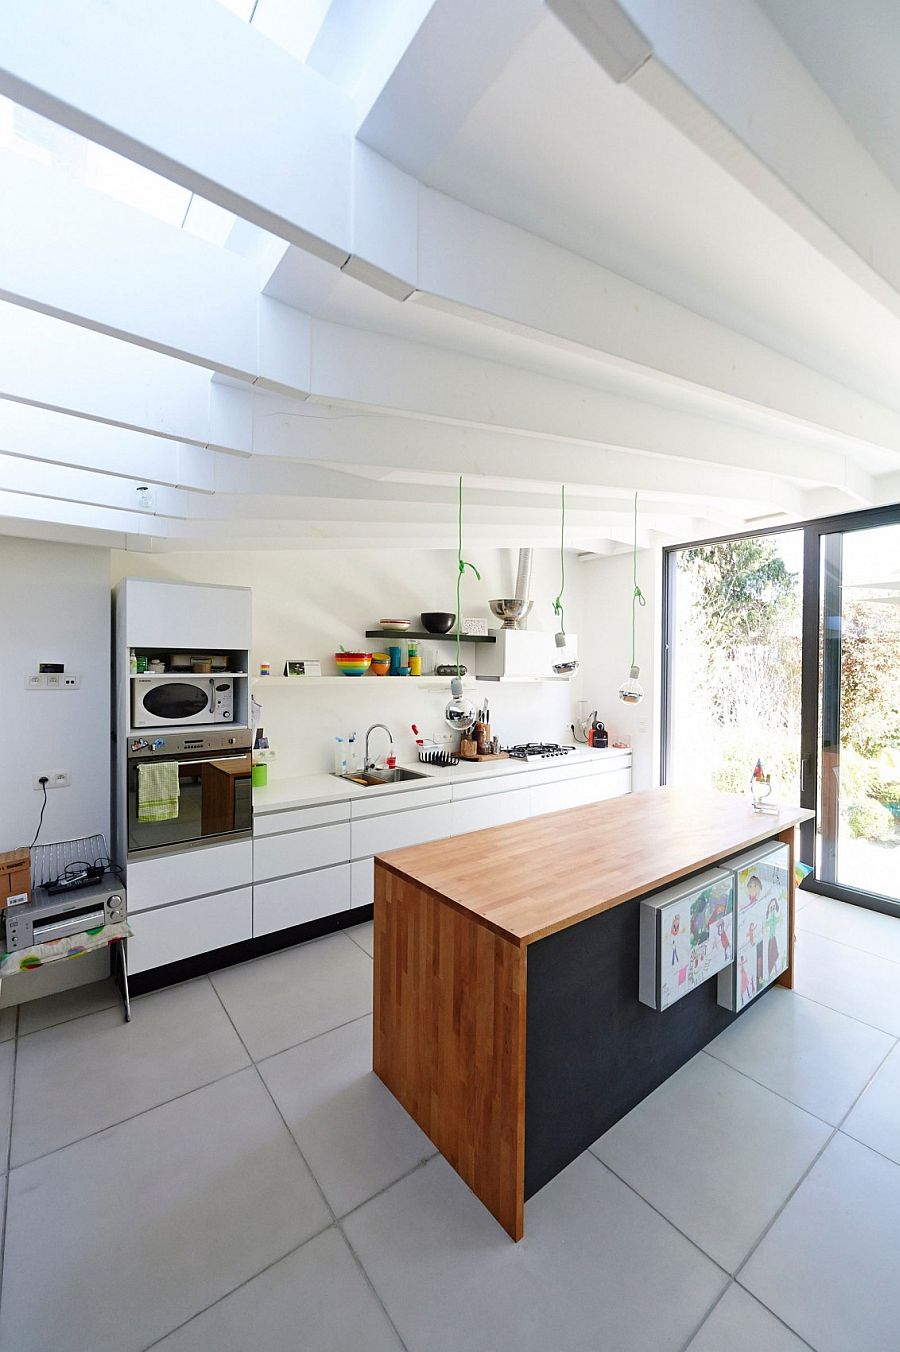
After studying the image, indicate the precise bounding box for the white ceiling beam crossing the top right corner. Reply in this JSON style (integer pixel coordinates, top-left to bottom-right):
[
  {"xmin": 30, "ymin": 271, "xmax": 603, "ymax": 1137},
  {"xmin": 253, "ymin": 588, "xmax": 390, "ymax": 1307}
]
[{"xmin": 547, "ymin": 0, "xmax": 900, "ymax": 315}]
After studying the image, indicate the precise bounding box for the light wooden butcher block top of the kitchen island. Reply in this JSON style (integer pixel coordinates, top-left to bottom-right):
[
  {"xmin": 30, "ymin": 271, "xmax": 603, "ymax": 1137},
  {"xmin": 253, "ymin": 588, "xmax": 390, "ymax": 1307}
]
[{"xmin": 376, "ymin": 788, "xmax": 815, "ymax": 945}]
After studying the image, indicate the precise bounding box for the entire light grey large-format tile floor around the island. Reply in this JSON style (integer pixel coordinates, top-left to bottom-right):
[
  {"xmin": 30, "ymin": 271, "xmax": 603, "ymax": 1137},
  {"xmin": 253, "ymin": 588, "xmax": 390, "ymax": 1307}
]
[{"xmin": 0, "ymin": 895, "xmax": 900, "ymax": 1352}]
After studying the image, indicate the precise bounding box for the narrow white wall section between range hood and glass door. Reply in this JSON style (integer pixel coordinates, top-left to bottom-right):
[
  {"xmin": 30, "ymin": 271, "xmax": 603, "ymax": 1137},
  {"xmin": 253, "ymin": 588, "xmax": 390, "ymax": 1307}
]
[{"xmin": 578, "ymin": 549, "xmax": 662, "ymax": 790}]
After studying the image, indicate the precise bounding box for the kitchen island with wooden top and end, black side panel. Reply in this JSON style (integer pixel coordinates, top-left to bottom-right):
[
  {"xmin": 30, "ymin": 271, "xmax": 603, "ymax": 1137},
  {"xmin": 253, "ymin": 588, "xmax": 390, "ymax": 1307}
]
[{"xmin": 373, "ymin": 788, "xmax": 812, "ymax": 1240}]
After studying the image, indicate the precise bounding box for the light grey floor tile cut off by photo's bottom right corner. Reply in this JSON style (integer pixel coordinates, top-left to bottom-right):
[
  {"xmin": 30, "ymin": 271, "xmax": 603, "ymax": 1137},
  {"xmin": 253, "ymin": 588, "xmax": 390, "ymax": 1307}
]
[{"xmin": 741, "ymin": 1134, "xmax": 900, "ymax": 1352}]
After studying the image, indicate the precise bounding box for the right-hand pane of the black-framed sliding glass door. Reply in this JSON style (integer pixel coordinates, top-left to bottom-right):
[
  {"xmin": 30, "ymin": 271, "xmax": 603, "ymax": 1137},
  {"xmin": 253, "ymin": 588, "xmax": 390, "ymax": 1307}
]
[{"xmin": 816, "ymin": 523, "xmax": 900, "ymax": 903}]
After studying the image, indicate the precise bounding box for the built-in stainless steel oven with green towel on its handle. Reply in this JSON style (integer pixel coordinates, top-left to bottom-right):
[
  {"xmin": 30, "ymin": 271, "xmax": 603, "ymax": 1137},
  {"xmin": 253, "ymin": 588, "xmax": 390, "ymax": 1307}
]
[{"xmin": 127, "ymin": 727, "xmax": 253, "ymax": 854}]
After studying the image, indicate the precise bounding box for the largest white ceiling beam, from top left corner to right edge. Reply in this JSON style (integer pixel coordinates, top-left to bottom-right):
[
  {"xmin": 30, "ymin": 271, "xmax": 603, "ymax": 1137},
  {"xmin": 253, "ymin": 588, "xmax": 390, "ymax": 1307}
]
[{"xmin": 7, "ymin": 0, "xmax": 900, "ymax": 449}]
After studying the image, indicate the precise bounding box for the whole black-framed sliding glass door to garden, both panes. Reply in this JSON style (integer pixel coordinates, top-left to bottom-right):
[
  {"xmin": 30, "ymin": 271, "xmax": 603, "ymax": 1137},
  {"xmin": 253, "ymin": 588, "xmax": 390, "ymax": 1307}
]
[{"xmin": 662, "ymin": 507, "xmax": 900, "ymax": 913}]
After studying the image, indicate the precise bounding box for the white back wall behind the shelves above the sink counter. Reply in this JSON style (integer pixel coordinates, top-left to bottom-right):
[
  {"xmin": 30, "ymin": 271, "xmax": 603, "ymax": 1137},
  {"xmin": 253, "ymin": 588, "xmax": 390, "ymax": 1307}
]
[{"xmin": 112, "ymin": 548, "xmax": 582, "ymax": 779}]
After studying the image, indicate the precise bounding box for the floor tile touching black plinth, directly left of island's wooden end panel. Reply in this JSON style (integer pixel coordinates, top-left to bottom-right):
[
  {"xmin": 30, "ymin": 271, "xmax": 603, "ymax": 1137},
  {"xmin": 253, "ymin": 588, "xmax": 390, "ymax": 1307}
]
[{"xmin": 212, "ymin": 934, "xmax": 372, "ymax": 1061}]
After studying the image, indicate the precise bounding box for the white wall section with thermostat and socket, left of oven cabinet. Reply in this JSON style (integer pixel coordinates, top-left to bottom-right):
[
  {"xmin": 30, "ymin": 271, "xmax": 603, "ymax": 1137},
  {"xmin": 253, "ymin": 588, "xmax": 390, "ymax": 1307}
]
[{"xmin": 0, "ymin": 535, "xmax": 109, "ymax": 849}]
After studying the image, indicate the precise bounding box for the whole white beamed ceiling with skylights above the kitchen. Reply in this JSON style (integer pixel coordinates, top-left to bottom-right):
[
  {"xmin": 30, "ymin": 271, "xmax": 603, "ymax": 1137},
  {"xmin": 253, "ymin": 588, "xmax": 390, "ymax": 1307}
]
[{"xmin": 0, "ymin": 0, "xmax": 900, "ymax": 549}]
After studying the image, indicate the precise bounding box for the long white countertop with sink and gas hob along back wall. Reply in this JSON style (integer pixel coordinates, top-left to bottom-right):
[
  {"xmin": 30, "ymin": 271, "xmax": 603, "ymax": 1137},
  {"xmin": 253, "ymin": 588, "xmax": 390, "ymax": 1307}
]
[{"xmin": 253, "ymin": 746, "xmax": 631, "ymax": 813}]
